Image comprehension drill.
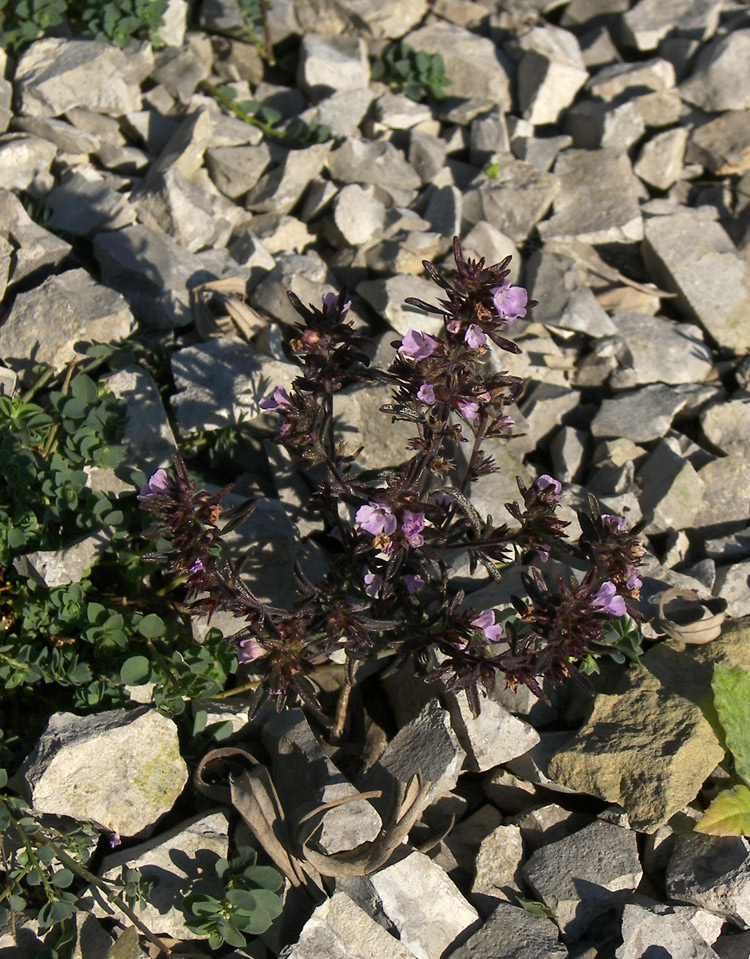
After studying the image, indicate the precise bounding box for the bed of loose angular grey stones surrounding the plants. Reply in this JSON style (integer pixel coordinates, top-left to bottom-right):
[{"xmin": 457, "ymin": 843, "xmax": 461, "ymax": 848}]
[{"xmin": 0, "ymin": 0, "xmax": 750, "ymax": 959}]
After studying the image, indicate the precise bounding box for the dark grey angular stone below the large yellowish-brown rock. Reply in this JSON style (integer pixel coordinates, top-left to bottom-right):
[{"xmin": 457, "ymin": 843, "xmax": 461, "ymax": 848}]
[{"xmin": 523, "ymin": 820, "xmax": 643, "ymax": 942}]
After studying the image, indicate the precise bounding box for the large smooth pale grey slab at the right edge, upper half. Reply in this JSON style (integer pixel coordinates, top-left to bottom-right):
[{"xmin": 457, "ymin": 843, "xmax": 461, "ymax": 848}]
[{"xmin": 643, "ymin": 209, "xmax": 750, "ymax": 352}]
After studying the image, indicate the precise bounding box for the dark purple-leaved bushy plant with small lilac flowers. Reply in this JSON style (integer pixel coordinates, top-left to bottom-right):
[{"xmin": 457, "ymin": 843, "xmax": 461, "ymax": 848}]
[{"xmin": 140, "ymin": 238, "xmax": 643, "ymax": 714}]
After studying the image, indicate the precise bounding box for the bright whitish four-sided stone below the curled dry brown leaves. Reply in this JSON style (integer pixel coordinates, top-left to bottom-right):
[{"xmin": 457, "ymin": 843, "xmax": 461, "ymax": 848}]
[{"xmin": 369, "ymin": 851, "xmax": 480, "ymax": 959}]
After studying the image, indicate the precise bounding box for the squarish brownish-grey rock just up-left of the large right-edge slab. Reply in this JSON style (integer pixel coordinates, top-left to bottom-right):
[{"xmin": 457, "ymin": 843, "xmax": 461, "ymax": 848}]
[{"xmin": 539, "ymin": 149, "xmax": 643, "ymax": 244}]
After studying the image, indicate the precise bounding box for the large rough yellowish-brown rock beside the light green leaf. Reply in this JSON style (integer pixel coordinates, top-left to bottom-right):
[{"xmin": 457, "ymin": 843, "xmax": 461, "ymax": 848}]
[{"xmin": 549, "ymin": 636, "xmax": 731, "ymax": 832}]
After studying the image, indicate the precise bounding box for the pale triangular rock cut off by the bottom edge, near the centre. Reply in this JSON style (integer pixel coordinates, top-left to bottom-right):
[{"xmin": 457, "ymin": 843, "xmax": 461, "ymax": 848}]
[{"xmin": 279, "ymin": 891, "xmax": 424, "ymax": 959}]
